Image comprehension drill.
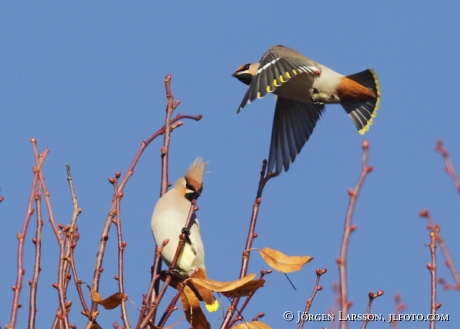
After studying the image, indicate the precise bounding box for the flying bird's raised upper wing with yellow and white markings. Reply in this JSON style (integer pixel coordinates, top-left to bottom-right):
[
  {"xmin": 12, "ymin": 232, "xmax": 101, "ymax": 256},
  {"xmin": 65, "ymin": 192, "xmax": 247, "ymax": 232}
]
[{"xmin": 237, "ymin": 46, "xmax": 321, "ymax": 112}]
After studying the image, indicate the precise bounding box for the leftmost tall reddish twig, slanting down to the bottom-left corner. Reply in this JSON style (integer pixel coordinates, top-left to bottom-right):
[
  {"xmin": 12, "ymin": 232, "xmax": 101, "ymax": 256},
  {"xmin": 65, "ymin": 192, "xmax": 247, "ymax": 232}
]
[{"xmin": 5, "ymin": 138, "xmax": 48, "ymax": 329}]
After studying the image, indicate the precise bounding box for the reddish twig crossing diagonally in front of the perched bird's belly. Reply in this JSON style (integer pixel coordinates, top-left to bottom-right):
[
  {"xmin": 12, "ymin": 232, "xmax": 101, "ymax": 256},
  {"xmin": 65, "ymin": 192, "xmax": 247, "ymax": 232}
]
[{"xmin": 140, "ymin": 200, "xmax": 198, "ymax": 328}]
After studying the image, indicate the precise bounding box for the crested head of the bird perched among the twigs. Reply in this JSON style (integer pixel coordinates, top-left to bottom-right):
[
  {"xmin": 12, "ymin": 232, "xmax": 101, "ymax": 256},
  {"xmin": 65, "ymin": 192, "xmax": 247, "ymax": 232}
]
[{"xmin": 175, "ymin": 158, "xmax": 206, "ymax": 201}]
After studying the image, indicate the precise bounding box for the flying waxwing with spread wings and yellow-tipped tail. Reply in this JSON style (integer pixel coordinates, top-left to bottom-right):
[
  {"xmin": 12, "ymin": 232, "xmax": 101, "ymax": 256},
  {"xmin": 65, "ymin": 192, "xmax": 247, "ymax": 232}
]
[{"xmin": 232, "ymin": 45, "xmax": 380, "ymax": 172}]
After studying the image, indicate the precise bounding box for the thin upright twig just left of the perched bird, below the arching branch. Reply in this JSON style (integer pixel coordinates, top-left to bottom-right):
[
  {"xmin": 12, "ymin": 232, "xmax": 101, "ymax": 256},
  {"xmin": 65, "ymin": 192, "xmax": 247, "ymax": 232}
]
[{"xmin": 113, "ymin": 178, "xmax": 131, "ymax": 329}]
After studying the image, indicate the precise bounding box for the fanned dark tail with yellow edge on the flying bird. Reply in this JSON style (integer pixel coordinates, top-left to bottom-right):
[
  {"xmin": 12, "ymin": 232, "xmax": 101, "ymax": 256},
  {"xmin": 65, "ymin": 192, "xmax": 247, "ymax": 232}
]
[{"xmin": 342, "ymin": 69, "xmax": 380, "ymax": 135}]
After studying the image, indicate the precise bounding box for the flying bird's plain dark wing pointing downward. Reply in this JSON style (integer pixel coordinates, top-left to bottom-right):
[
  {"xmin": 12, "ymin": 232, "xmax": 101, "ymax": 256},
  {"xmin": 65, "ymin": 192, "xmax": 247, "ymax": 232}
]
[{"xmin": 268, "ymin": 97, "xmax": 324, "ymax": 172}]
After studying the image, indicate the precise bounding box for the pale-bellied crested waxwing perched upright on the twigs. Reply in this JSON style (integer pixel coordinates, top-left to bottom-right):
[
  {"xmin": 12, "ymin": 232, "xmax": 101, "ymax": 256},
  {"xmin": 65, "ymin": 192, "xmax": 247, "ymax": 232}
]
[{"xmin": 151, "ymin": 158, "xmax": 219, "ymax": 312}]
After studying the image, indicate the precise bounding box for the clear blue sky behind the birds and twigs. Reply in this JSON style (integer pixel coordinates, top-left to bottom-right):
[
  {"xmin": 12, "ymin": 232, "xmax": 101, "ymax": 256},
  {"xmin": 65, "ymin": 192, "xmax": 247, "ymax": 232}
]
[{"xmin": 0, "ymin": 1, "xmax": 460, "ymax": 328}]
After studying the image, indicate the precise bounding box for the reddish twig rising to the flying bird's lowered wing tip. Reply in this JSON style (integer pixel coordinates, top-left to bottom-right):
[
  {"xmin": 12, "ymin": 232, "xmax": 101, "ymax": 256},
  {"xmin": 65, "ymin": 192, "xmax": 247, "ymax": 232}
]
[{"xmin": 220, "ymin": 160, "xmax": 279, "ymax": 329}]
